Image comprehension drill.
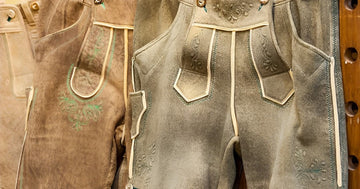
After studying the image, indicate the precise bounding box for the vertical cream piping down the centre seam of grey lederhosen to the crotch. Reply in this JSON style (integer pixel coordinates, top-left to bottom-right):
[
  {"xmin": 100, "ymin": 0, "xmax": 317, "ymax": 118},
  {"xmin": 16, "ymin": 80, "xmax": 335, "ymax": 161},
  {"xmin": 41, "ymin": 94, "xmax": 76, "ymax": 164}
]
[{"xmin": 230, "ymin": 31, "xmax": 239, "ymax": 136}]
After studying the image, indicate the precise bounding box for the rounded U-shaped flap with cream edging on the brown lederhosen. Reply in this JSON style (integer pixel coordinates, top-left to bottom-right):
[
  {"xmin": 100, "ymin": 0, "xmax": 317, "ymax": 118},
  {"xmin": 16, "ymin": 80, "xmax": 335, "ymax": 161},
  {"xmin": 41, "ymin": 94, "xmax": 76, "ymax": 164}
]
[{"xmin": 70, "ymin": 24, "xmax": 116, "ymax": 98}]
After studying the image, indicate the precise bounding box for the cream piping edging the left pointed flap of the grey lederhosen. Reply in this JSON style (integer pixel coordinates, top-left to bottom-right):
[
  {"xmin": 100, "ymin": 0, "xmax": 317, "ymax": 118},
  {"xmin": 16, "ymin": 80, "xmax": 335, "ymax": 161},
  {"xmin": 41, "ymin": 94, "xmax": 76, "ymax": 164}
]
[{"xmin": 173, "ymin": 28, "xmax": 216, "ymax": 102}]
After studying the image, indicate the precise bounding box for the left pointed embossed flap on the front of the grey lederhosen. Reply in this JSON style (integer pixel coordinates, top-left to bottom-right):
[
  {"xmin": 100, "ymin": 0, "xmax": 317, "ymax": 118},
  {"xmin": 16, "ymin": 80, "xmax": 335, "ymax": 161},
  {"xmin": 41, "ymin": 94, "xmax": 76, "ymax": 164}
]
[{"xmin": 174, "ymin": 26, "xmax": 216, "ymax": 102}]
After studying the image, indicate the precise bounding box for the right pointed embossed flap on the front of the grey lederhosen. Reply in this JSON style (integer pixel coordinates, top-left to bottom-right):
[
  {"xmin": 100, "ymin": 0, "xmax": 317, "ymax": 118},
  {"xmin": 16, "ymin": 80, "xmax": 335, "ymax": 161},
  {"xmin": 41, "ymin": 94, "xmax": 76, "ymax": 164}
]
[{"xmin": 250, "ymin": 26, "xmax": 294, "ymax": 105}]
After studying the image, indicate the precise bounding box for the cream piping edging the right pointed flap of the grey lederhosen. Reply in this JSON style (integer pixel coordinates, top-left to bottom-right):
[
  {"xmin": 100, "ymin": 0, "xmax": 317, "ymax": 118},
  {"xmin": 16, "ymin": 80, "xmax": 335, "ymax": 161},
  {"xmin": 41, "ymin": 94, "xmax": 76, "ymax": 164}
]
[{"xmin": 250, "ymin": 29, "xmax": 295, "ymax": 105}]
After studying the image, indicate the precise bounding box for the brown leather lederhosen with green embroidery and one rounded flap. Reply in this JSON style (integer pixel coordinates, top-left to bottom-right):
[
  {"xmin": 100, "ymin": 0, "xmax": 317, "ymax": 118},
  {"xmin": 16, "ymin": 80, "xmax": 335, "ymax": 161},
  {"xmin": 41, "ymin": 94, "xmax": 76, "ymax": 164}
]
[{"xmin": 17, "ymin": 0, "xmax": 135, "ymax": 188}]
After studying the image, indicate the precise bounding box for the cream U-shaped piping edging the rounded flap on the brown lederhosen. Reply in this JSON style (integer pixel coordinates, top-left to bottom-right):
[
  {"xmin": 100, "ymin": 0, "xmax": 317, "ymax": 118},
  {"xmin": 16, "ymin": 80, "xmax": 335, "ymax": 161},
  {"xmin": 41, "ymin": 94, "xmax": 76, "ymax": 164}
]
[{"xmin": 70, "ymin": 28, "xmax": 114, "ymax": 98}]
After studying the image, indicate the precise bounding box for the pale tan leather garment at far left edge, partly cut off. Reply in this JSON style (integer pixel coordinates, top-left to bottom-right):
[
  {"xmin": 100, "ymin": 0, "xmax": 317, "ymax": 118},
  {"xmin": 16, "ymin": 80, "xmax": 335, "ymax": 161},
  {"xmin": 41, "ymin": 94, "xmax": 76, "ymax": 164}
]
[{"xmin": 0, "ymin": 0, "xmax": 39, "ymax": 188}]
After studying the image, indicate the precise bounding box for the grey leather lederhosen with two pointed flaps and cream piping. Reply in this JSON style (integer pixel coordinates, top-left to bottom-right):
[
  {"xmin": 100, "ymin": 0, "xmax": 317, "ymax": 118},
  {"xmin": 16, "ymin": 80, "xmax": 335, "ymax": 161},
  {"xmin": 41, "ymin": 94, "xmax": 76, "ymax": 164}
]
[{"xmin": 128, "ymin": 0, "xmax": 347, "ymax": 189}]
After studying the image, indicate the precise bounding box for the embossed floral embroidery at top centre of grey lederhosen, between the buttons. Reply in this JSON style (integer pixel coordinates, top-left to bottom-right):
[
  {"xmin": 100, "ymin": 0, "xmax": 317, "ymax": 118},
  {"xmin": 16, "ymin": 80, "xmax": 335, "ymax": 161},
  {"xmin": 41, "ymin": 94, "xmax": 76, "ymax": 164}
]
[{"xmin": 213, "ymin": 2, "xmax": 254, "ymax": 23}]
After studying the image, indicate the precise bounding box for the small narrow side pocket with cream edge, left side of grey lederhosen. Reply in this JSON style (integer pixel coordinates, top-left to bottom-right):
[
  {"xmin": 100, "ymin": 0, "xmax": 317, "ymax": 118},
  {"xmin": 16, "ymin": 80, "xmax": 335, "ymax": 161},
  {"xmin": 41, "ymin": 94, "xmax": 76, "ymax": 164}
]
[{"xmin": 129, "ymin": 90, "xmax": 147, "ymax": 140}]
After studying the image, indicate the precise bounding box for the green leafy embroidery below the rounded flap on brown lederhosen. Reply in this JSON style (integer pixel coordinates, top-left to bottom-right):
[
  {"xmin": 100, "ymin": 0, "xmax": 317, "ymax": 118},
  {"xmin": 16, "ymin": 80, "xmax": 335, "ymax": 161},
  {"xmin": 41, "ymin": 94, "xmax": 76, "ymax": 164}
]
[{"xmin": 59, "ymin": 94, "xmax": 102, "ymax": 131}]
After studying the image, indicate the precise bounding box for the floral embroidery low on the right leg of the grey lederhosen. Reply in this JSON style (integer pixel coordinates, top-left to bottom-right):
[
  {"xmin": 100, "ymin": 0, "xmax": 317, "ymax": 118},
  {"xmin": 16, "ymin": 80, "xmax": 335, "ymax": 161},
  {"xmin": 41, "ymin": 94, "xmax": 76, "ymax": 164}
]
[{"xmin": 294, "ymin": 147, "xmax": 327, "ymax": 186}]
